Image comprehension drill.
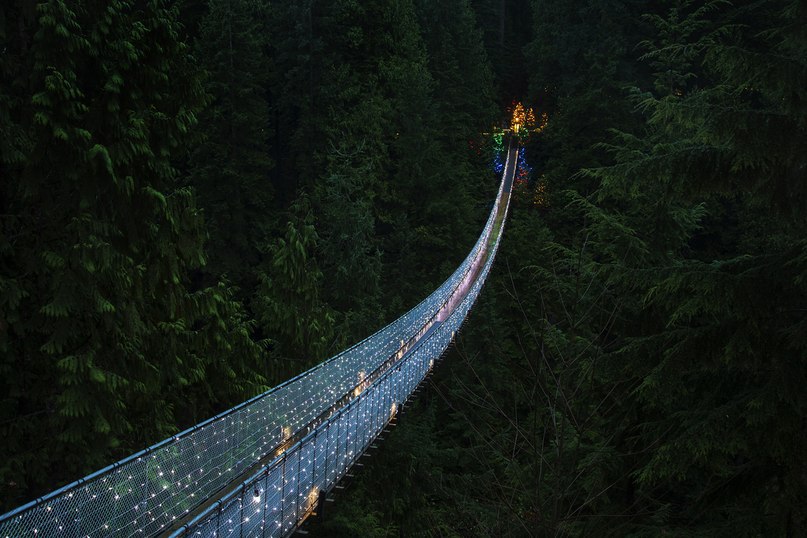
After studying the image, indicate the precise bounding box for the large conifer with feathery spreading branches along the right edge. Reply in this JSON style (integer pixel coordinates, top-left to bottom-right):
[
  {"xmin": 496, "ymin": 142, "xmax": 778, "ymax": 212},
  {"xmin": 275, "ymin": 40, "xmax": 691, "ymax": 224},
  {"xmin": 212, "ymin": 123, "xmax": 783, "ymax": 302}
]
[{"xmin": 580, "ymin": 2, "xmax": 807, "ymax": 535}]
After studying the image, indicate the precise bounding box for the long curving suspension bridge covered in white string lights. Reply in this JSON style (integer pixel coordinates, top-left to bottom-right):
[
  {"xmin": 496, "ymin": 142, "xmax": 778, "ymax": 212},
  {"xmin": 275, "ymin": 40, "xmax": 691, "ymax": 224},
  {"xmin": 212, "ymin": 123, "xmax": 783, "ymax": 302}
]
[{"xmin": 0, "ymin": 140, "xmax": 518, "ymax": 538}]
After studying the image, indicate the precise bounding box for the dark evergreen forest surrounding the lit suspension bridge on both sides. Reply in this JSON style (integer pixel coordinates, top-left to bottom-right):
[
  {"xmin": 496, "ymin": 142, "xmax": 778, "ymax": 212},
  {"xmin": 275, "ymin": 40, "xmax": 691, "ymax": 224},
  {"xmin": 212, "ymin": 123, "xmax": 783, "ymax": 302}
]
[{"xmin": 0, "ymin": 0, "xmax": 807, "ymax": 536}]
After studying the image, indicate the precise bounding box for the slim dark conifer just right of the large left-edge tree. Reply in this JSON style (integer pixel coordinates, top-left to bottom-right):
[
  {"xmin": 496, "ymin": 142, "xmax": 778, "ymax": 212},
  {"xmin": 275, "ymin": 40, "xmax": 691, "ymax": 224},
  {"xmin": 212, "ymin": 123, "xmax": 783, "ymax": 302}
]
[{"xmin": 190, "ymin": 0, "xmax": 274, "ymax": 296}]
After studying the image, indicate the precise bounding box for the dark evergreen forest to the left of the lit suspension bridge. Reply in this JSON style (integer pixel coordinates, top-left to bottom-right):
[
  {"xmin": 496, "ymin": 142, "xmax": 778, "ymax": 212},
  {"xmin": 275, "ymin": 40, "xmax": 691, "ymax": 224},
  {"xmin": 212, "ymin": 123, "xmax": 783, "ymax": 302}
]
[{"xmin": 0, "ymin": 0, "xmax": 496, "ymax": 509}]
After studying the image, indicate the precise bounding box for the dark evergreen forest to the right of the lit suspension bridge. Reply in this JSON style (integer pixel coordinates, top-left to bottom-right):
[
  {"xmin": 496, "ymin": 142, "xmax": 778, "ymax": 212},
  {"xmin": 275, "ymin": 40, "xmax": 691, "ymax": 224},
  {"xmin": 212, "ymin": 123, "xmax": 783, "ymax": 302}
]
[{"xmin": 322, "ymin": 0, "xmax": 807, "ymax": 536}]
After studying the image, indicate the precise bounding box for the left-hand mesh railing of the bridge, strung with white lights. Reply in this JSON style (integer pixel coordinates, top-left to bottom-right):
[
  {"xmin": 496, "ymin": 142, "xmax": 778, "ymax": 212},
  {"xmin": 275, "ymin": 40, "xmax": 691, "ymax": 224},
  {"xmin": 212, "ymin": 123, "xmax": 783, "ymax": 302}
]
[{"xmin": 0, "ymin": 143, "xmax": 516, "ymax": 537}]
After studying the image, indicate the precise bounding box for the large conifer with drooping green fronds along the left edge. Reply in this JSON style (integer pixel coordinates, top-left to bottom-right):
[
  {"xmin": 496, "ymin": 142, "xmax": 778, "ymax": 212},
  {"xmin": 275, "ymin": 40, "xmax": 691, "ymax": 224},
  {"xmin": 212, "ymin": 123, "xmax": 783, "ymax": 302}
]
[{"xmin": 0, "ymin": 0, "xmax": 260, "ymax": 507}]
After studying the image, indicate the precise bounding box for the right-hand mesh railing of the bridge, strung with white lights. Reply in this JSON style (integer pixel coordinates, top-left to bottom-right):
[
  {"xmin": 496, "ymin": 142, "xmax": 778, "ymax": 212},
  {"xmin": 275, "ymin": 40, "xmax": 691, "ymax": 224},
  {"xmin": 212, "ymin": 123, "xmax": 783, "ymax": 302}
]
[{"xmin": 171, "ymin": 140, "xmax": 510, "ymax": 538}]
